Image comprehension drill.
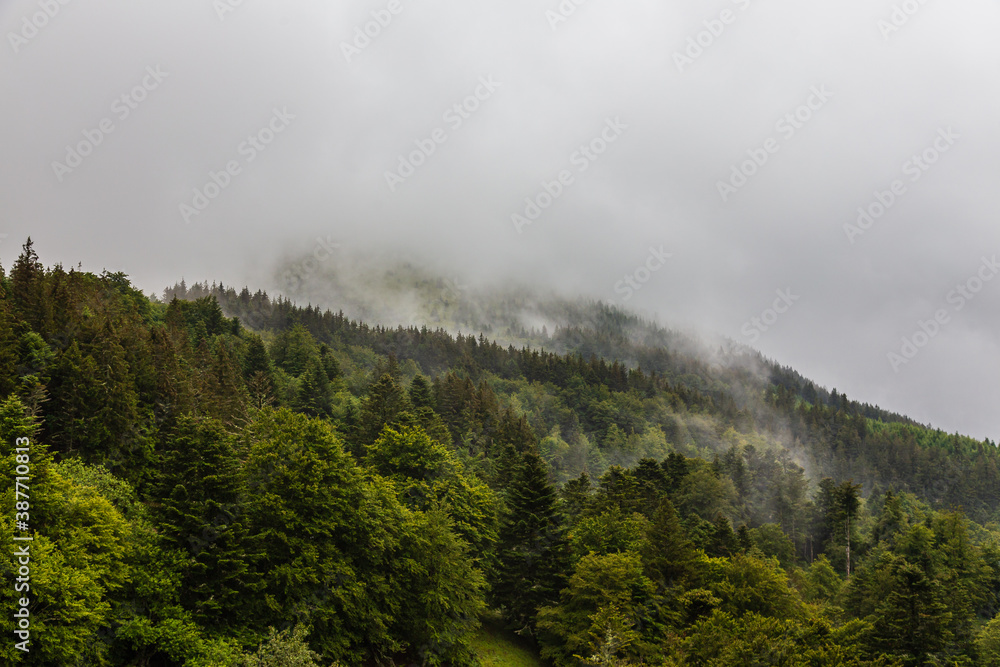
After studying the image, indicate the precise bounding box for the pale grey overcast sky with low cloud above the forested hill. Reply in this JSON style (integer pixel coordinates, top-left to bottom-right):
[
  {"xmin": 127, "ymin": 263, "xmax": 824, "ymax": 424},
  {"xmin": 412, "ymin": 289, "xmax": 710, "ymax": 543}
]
[{"xmin": 0, "ymin": 0, "xmax": 1000, "ymax": 440}]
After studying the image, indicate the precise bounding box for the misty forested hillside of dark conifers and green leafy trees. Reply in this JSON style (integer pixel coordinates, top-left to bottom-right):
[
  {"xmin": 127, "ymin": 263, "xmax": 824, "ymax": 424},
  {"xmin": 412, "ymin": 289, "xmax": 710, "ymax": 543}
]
[{"xmin": 0, "ymin": 240, "xmax": 1000, "ymax": 667}]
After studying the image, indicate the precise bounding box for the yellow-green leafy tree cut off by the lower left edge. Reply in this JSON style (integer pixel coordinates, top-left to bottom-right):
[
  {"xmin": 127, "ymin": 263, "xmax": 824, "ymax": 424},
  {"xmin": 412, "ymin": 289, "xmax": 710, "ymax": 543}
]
[{"xmin": 0, "ymin": 397, "xmax": 131, "ymax": 667}]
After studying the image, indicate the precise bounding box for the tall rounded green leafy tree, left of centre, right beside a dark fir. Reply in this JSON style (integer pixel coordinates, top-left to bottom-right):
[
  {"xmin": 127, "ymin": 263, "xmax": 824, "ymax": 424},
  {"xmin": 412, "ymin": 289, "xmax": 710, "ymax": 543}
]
[{"xmin": 242, "ymin": 409, "xmax": 398, "ymax": 662}]
